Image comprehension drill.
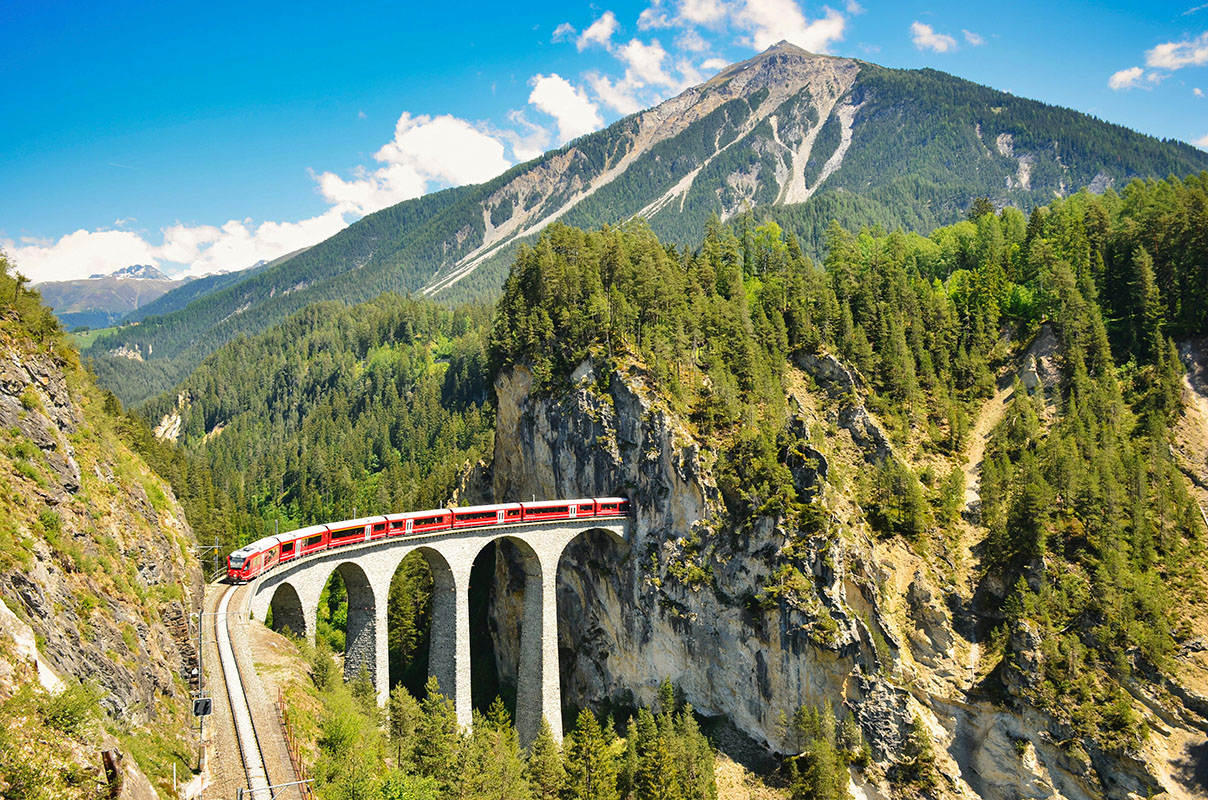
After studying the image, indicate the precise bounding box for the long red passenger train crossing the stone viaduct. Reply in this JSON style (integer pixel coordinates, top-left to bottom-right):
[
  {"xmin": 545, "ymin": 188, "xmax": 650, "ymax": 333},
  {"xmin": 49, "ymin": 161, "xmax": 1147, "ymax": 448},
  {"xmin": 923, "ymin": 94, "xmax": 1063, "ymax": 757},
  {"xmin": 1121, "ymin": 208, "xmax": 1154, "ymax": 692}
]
[{"xmin": 227, "ymin": 497, "xmax": 629, "ymax": 584}]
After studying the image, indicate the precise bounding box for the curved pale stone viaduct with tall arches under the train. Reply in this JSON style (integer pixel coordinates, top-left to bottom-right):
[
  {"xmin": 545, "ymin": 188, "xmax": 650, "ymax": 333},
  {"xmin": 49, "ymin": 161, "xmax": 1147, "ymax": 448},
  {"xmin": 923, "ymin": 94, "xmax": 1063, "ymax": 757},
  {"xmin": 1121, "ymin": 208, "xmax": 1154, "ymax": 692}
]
[{"xmin": 241, "ymin": 517, "xmax": 629, "ymax": 744}]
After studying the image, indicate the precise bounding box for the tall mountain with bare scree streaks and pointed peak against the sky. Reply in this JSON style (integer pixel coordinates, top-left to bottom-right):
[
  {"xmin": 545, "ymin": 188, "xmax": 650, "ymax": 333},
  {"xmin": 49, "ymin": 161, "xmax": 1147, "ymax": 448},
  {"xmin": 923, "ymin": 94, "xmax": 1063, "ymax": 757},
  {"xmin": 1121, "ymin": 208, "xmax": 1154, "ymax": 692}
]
[{"xmin": 87, "ymin": 42, "xmax": 1208, "ymax": 404}]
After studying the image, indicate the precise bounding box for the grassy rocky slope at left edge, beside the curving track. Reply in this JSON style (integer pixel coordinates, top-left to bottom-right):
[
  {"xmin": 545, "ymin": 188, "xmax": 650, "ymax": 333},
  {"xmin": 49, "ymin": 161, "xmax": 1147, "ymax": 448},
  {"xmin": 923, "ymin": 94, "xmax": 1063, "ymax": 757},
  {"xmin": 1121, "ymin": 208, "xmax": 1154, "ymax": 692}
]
[{"xmin": 0, "ymin": 254, "xmax": 202, "ymax": 798}]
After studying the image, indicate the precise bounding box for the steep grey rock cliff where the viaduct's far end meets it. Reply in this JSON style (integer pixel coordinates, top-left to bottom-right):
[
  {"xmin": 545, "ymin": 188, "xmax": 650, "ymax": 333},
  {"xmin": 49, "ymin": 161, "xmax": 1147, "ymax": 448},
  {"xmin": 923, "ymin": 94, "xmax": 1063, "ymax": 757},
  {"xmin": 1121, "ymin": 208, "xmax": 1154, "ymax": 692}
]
[{"xmin": 490, "ymin": 358, "xmax": 1208, "ymax": 800}]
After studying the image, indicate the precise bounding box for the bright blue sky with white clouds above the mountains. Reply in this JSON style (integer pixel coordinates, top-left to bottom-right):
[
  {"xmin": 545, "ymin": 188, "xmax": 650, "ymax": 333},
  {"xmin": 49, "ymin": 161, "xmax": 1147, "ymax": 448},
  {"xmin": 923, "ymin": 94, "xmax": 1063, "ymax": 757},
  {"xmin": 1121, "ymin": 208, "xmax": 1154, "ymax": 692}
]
[{"xmin": 0, "ymin": 0, "xmax": 1208, "ymax": 280}]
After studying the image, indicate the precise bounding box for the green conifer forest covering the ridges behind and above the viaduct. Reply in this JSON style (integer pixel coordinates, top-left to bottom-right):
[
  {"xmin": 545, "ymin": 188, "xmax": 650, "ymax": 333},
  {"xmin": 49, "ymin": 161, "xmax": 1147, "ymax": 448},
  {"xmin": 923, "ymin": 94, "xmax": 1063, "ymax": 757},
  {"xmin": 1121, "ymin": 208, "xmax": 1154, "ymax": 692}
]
[{"xmin": 117, "ymin": 173, "xmax": 1208, "ymax": 798}]
